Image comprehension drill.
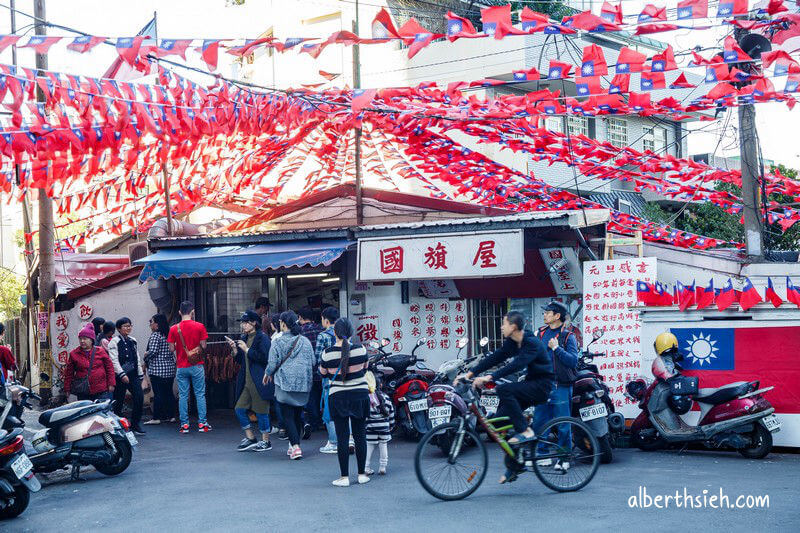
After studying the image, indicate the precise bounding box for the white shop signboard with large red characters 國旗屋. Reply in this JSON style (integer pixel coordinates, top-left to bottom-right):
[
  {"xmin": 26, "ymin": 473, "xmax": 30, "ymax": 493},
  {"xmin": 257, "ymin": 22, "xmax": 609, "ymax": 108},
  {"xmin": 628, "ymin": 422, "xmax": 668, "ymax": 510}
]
[{"xmin": 357, "ymin": 230, "xmax": 524, "ymax": 281}]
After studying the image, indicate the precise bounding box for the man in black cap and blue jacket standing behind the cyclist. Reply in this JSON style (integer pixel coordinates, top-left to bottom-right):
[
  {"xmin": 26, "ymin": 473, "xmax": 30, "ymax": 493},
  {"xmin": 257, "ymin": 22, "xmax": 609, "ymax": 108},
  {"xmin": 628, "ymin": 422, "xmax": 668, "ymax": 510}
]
[{"xmin": 533, "ymin": 301, "xmax": 579, "ymax": 471}]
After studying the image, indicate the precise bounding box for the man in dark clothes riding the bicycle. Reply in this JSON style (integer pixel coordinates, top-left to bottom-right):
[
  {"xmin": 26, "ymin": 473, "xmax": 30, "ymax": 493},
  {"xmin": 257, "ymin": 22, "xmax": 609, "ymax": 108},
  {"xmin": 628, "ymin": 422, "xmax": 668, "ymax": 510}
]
[{"xmin": 467, "ymin": 311, "xmax": 555, "ymax": 444}]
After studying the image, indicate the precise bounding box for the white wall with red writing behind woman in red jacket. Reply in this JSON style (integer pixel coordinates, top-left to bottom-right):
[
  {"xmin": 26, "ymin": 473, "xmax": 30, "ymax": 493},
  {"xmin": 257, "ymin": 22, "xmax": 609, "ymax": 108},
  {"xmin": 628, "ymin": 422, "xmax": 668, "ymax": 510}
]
[{"xmin": 50, "ymin": 279, "xmax": 156, "ymax": 391}]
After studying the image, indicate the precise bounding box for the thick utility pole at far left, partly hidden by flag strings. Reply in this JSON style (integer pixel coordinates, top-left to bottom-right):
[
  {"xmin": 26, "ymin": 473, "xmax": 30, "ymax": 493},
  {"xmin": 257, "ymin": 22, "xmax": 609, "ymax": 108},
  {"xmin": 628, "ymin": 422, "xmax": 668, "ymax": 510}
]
[{"xmin": 33, "ymin": 0, "xmax": 56, "ymax": 304}]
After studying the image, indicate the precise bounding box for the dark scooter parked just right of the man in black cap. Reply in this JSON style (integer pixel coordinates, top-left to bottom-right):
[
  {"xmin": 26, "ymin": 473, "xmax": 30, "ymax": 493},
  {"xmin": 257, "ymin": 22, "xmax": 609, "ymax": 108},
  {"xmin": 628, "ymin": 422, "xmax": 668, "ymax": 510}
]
[{"xmin": 571, "ymin": 329, "xmax": 625, "ymax": 463}]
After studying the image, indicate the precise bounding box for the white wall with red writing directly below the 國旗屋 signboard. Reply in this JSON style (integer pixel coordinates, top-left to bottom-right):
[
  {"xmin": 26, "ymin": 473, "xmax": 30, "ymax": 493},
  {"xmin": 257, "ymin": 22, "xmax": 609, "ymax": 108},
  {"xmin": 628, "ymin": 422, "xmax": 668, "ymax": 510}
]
[{"xmin": 350, "ymin": 281, "xmax": 469, "ymax": 369}]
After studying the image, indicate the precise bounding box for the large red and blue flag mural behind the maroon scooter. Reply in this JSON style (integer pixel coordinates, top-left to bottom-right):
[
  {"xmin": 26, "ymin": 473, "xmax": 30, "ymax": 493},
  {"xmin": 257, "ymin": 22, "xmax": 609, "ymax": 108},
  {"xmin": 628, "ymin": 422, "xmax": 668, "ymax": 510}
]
[{"xmin": 671, "ymin": 327, "xmax": 800, "ymax": 414}]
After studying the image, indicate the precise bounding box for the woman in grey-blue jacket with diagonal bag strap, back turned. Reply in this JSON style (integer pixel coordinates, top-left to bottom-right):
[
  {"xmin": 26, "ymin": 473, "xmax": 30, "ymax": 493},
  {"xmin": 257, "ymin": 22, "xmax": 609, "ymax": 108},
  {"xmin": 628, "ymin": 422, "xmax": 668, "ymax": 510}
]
[{"xmin": 263, "ymin": 311, "xmax": 314, "ymax": 459}]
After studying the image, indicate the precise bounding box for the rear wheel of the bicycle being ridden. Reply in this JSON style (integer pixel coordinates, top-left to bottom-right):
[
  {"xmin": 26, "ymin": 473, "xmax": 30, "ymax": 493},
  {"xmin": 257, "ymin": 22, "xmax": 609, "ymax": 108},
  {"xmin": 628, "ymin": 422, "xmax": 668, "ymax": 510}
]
[{"xmin": 531, "ymin": 416, "xmax": 602, "ymax": 492}]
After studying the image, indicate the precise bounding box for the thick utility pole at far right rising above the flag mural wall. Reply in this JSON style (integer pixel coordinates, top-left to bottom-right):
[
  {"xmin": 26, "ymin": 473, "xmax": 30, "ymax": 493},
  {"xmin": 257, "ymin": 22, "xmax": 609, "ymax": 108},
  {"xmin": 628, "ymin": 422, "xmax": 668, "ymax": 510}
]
[{"xmin": 734, "ymin": 28, "xmax": 764, "ymax": 259}]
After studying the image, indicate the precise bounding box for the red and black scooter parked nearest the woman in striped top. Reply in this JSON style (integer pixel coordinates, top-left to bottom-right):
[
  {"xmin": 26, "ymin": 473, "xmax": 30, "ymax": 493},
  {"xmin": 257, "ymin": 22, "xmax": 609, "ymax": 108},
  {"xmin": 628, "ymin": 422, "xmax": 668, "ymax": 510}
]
[{"xmin": 374, "ymin": 338, "xmax": 434, "ymax": 440}]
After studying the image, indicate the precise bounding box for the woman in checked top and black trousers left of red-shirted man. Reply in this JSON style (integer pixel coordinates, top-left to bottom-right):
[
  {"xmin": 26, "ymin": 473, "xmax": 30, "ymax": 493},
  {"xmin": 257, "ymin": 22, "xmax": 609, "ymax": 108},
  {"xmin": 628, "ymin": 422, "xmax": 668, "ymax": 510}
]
[{"xmin": 144, "ymin": 314, "xmax": 177, "ymax": 424}]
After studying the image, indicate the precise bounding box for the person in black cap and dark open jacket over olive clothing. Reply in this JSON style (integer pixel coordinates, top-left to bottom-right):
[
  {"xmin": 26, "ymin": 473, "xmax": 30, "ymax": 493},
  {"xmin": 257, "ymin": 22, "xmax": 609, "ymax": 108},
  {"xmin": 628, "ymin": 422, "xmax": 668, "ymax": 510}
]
[{"xmin": 225, "ymin": 310, "xmax": 275, "ymax": 452}]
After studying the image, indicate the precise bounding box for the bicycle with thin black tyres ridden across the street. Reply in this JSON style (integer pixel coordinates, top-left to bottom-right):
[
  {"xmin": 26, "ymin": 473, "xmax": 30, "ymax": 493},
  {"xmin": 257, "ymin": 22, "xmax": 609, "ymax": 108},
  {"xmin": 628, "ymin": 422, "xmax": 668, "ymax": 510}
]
[{"xmin": 414, "ymin": 381, "xmax": 601, "ymax": 501}]
